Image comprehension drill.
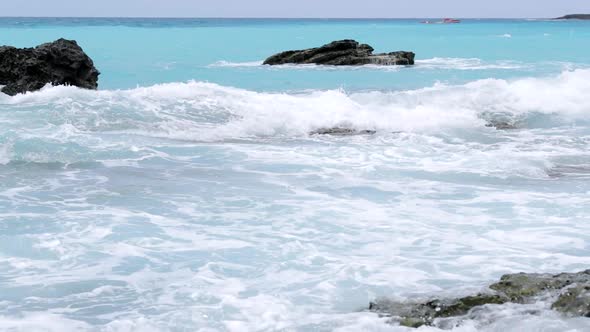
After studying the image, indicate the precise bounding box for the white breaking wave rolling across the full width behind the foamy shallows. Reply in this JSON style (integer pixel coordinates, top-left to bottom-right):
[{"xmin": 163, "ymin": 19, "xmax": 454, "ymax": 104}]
[{"xmin": 0, "ymin": 69, "xmax": 590, "ymax": 140}]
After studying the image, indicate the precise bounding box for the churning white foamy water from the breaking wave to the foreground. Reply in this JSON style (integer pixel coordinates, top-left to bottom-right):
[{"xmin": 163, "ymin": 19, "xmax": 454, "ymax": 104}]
[{"xmin": 0, "ymin": 70, "xmax": 590, "ymax": 332}]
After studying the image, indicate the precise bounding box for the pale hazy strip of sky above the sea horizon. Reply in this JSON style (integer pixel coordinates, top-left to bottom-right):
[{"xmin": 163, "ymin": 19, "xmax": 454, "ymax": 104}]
[{"xmin": 0, "ymin": 0, "xmax": 590, "ymax": 18}]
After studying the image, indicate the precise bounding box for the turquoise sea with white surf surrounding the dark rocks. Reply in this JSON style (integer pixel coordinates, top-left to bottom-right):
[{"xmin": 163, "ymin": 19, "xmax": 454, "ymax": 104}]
[{"xmin": 0, "ymin": 18, "xmax": 590, "ymax": 332}]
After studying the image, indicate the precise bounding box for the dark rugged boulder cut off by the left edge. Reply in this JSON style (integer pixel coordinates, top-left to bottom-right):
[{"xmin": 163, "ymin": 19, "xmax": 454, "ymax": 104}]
[{"xmin": 0, "ymin": 39, "xmax": 100, "ymax": 96}]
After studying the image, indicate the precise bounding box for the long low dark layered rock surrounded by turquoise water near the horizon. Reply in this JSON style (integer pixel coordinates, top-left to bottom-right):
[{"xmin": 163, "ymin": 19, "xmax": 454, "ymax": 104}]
[{"xmin": 264, "ymin": 39, "xmax": 415, "ymax": 66}]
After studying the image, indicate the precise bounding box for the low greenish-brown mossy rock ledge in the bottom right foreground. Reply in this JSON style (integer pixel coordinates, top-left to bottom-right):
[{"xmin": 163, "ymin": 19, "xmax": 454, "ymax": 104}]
[{"xmin": 369, "ymin": 270, "xmax": 590, "ymax": 327}]
